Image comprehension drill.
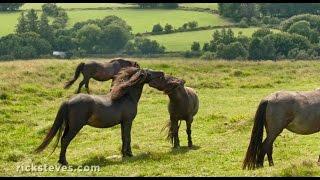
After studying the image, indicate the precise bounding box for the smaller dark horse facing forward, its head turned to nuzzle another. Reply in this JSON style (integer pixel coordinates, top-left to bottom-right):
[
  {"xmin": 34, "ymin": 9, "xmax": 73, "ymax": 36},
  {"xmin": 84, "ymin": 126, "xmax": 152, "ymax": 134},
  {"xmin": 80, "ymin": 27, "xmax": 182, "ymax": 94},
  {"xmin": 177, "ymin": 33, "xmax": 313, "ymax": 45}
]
[{"xmin": 149, "ymin": 75, "xmax": 199, "ymax": 148}]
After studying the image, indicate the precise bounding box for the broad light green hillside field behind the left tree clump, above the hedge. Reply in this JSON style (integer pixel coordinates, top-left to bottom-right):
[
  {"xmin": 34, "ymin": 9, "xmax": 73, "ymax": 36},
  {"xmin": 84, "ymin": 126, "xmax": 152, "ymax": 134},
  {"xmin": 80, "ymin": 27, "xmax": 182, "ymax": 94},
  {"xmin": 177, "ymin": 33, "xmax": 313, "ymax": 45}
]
[{"xmin": 0, "ymin": 9, "xmax": 230, "ymax": 35}]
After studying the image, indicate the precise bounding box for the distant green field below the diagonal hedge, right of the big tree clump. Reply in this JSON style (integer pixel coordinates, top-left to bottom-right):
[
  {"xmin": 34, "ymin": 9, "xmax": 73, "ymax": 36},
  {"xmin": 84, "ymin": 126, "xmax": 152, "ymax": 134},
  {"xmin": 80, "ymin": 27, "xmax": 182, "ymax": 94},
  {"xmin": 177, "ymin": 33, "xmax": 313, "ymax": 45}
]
[{"xmin": 148, "ymin": 28, "xmax": 278, "ymax": 51}]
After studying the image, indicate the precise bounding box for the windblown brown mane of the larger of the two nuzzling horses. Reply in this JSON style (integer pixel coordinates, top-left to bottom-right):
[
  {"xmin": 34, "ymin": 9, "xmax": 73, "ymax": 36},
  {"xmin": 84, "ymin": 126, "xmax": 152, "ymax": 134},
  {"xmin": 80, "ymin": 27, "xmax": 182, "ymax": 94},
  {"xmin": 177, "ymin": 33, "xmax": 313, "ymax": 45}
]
[{"xmin": 110, "ymin": 67, "xmax": 146, "ymax": 100}]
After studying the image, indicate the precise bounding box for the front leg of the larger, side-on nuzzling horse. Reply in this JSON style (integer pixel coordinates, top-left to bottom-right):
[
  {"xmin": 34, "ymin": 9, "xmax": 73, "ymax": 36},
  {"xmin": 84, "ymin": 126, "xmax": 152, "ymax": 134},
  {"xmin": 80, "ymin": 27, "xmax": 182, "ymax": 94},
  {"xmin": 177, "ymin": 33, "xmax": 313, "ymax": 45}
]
[{"xmin": 121, "ymin": 121, "xmax": 133, "ymax": 157}]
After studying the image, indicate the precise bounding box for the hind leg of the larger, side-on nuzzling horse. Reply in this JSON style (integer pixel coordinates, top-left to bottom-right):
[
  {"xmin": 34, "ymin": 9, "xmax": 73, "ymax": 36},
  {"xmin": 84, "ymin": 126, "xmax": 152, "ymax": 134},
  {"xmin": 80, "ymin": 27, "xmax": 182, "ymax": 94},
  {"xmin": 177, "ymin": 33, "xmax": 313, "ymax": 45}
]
[{"xmin": 58, "ymin": 120, "xmax": 83, "ymax": 165}]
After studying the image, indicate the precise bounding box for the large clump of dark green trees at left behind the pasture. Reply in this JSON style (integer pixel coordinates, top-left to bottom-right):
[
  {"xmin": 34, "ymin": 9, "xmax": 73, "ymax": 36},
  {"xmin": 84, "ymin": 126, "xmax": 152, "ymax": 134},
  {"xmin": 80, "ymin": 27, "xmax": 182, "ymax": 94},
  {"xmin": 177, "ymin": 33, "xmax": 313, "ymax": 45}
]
[{"xmin": 0, "ymin": 3, "xmax": 165, "ymax": 59}]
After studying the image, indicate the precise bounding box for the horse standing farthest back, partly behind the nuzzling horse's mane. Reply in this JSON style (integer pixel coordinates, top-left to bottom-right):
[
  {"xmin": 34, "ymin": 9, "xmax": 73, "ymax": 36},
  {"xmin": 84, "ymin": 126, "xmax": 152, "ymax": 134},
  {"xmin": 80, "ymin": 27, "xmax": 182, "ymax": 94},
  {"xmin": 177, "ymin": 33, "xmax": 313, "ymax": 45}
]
[{"xmin": 64, "ymin": 58, "xmax": 140, "ymax": 93}]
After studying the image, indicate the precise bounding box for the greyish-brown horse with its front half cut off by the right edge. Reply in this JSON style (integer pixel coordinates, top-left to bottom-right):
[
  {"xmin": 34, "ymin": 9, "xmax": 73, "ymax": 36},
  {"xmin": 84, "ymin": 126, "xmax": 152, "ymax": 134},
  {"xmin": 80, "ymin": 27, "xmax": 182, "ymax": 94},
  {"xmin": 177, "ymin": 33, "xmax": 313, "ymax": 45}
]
[{"xmin": 243, "ymin": 89, "xmax": 320, "ymax": 169}]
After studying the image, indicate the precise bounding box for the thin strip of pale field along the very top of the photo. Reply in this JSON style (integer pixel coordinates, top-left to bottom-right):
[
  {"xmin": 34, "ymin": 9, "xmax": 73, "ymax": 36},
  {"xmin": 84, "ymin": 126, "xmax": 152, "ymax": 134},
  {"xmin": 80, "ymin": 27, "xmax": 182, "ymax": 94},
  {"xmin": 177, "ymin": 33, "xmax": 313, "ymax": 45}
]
[{"xmin": 21, "ymin": 3, "xmax": 136, "ymax": 10}]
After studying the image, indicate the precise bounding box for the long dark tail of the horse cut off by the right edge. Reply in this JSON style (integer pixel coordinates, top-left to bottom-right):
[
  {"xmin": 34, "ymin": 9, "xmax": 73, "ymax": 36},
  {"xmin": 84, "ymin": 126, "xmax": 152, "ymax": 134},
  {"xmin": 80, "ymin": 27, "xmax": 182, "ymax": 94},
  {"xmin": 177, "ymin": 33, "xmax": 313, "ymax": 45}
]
[{"xmin": 242, "ymin": 100, "xmax": 268, "ymax": 169}]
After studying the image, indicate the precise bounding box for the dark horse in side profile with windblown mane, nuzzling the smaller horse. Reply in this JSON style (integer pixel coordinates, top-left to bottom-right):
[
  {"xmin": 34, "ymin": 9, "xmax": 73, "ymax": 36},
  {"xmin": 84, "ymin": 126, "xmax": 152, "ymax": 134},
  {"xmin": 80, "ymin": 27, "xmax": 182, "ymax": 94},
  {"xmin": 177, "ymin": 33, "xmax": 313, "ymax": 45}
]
[{"xmin": 35, "ymin": 67, "xmax": 164, "ymax": 165}]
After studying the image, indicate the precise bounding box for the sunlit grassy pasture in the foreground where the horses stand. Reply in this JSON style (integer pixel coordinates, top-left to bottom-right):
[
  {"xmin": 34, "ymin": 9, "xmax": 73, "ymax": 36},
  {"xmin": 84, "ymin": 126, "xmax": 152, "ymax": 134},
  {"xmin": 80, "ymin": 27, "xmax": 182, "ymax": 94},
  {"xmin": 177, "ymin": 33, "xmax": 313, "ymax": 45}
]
[{"xmin": 0, "ymin": 58, "xmax": 320, "ymax": 176}]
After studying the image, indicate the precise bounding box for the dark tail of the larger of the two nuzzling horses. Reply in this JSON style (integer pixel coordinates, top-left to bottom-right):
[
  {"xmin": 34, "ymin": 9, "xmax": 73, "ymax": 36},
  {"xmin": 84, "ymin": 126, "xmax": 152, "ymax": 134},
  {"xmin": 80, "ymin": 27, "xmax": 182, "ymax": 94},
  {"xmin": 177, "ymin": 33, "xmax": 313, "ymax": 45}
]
[{"xmin": 35, "ymin": 102, "xmax": 68, "ymax": 154}]
